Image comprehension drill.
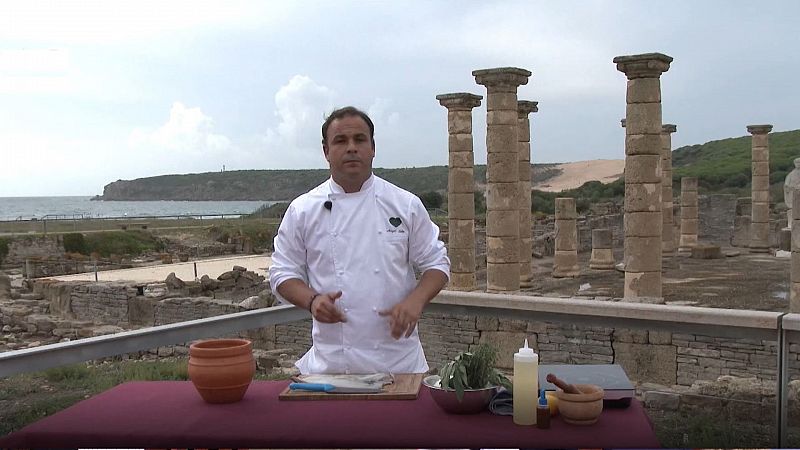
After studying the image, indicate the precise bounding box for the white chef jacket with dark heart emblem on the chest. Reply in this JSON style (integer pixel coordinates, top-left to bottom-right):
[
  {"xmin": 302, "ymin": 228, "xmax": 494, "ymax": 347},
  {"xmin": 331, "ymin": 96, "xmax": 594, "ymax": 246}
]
[{"xmin": 269, "ymin": 175, "xmax": 450, "ymax": 374}]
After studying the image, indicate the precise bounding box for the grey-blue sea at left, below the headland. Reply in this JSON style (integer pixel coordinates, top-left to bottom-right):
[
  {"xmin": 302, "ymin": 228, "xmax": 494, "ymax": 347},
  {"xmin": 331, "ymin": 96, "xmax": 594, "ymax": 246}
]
[{"xmin": 0, "ymin": 196, "xmax": 276, "ymax": 221}]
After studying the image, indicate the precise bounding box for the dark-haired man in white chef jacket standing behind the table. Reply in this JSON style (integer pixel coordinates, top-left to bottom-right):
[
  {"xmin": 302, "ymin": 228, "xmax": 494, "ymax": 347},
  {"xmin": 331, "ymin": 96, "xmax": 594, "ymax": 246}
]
[{"xmin": 269, "ymin": 107, "xmax": 450, "ymax": 374}]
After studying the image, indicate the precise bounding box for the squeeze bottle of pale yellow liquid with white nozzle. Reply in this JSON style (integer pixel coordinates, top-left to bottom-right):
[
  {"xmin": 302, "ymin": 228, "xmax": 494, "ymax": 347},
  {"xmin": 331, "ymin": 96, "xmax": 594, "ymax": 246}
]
[{"xmin": 514, "ymin": 339, "xmax": 539, "ymax": 425}]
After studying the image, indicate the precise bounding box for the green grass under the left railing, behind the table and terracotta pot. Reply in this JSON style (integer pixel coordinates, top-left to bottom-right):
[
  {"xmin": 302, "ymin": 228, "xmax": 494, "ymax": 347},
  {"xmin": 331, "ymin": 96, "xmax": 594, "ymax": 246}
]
[{"xmin": 0, "ymin": 358, "xmax": 288, "ymax": 436}]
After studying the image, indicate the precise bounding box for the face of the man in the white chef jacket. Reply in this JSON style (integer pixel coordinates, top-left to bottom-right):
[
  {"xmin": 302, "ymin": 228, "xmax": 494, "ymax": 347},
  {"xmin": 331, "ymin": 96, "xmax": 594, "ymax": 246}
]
[{"xmin": 322, "ymin": 116, "xmax": 375, "ymax": 188}]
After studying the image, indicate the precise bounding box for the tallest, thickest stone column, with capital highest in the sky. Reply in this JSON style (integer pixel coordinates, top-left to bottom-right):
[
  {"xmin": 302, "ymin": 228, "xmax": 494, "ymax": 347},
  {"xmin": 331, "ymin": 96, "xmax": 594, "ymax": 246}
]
[{"xmin": 614, "ymin": 53, "xmax": 672, "ymax": 298}]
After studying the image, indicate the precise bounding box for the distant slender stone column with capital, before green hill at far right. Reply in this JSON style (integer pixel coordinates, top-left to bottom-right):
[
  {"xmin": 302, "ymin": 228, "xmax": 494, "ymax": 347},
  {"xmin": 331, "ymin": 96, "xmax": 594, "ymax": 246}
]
[{"xmin": 747, "ymin": 125, "xmax": 772, "ymax": 253}]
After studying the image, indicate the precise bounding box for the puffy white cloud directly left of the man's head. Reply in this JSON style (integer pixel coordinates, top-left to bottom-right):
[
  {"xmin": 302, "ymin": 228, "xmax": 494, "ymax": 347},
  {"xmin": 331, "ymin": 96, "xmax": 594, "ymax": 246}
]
[{"xmin": 260, "ymin": 75, "xmax": 336, "ymax": 169}]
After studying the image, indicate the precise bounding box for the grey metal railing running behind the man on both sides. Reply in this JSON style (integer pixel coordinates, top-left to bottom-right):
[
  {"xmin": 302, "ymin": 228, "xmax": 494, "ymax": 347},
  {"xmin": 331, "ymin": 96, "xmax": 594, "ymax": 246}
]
[{"xmin": 0, "ymin": 291, "xmax": 800, "ymax": 447}]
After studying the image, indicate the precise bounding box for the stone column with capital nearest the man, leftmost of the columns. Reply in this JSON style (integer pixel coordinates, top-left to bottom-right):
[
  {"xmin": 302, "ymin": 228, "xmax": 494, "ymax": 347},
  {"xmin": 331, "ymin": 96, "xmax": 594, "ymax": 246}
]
[{"xmin": 436, "ymin": 92, "xmax": 483, "ymax": 291}]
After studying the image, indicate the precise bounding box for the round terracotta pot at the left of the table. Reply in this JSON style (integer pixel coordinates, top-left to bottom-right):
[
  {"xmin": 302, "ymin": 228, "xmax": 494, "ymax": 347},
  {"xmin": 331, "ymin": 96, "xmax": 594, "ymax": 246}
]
[{"xmin": 189, "ymin": 339, "xmax": 256, "ymax": 403}]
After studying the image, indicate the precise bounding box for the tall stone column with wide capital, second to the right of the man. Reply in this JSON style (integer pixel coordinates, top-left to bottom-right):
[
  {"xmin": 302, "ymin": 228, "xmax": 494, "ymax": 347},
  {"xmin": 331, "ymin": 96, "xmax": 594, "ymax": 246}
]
[{"xmin": 472, "ymin": 67, "xmax": 531, "ymax": 292}]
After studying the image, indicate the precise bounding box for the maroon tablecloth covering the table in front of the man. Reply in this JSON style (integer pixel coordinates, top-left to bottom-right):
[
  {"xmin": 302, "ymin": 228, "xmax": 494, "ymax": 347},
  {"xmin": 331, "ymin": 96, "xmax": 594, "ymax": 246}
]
[{"xmin": 0, "ymin": 381, "xmax": 659, "ymax": 448}]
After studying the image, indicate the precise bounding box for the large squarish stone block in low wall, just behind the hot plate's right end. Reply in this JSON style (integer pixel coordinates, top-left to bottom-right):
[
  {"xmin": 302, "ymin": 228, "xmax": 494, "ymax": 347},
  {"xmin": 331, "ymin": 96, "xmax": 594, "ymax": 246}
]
[{"xmin": 614, "ymin": 342, "xmax": 677, "ymax": 386}]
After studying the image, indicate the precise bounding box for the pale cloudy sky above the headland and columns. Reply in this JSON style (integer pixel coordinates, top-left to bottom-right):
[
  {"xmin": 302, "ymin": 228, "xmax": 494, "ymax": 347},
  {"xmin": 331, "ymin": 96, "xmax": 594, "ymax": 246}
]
[{"xmin": 0, "ymin": 0, "xmax": 800, "ymax": 197}]
